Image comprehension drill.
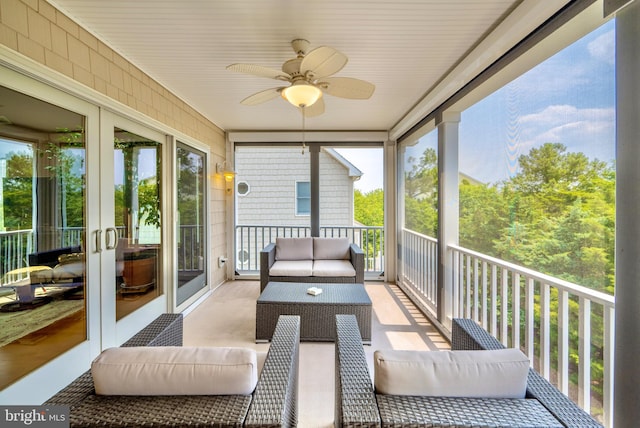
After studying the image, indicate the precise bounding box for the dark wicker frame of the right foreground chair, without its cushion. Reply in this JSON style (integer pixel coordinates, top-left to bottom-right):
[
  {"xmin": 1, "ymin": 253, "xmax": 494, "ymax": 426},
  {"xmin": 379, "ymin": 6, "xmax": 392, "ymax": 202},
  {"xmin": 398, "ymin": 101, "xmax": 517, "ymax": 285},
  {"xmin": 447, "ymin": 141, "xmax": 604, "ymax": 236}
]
[{"xmin": 335, "ymin": 315, "xmax": 602, "ymax": 428}]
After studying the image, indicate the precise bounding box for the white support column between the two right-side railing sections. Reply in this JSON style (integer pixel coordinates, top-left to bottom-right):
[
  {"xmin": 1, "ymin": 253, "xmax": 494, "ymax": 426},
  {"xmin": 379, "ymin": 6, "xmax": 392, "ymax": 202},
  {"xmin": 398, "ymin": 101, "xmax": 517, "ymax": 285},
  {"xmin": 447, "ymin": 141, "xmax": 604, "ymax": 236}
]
[{"xmin": 436, "ymin": 112, "xmax": 460, "ymax": 328}]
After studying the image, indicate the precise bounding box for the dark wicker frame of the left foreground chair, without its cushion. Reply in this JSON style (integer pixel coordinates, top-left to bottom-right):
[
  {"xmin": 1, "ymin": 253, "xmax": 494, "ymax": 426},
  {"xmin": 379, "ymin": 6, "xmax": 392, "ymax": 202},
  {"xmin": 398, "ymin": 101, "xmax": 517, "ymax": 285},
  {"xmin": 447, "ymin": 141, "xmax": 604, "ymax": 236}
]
[{"xmin": 45, "ymin": 314, "xmax": 300, "ymax": 427}]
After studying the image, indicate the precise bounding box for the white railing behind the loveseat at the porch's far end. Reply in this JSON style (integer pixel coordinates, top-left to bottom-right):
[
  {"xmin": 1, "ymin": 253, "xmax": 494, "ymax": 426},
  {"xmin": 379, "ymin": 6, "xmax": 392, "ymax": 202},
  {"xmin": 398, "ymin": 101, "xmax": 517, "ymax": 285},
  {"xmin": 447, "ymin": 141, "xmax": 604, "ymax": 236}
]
[{"xmin": 235, "ymin": 225, "xmax": 384, "ymax": 275}]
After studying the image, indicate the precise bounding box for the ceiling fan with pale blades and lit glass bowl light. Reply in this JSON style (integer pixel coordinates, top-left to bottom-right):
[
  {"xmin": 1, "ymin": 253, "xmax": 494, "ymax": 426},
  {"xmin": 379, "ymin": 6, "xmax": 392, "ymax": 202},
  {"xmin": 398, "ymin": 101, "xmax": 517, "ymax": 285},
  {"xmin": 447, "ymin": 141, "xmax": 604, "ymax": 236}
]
[{"xmin": 227, "ymin": 39, "xmax": 375, "ymax": 117}]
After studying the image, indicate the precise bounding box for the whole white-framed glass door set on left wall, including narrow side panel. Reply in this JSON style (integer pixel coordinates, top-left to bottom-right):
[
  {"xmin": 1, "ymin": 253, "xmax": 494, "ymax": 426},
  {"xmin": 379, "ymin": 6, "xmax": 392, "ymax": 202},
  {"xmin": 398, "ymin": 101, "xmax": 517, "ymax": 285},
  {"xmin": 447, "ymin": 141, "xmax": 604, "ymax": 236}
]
[{"xmin": 0, "ymin": 66, "xmax": 208, "ymax": 404}]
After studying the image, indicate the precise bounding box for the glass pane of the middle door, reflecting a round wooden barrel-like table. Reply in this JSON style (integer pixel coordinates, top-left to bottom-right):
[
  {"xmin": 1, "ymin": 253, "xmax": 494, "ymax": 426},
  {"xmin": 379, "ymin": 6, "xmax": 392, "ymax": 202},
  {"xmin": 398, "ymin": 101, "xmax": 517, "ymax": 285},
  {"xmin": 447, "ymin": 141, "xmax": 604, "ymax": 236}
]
[{"xmin": 114, "ymin": 127, "xmax": 163, "ymax": 320}]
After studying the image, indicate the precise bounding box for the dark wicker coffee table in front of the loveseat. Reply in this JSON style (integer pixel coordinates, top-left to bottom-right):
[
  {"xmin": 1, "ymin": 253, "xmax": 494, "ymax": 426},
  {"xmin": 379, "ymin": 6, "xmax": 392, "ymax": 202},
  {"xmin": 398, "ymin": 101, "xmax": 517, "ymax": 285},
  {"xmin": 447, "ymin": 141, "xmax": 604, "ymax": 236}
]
[{"xmin": 256, "ymin": 282, "xmax": 371, "ymax": 344}]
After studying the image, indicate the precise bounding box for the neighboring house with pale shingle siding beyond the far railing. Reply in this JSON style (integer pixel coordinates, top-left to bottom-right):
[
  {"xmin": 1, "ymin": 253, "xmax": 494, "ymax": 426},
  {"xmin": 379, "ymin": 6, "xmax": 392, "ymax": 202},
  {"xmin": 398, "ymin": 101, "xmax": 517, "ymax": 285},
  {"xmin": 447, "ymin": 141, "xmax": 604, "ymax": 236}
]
[{"xmin": 235, "ymin": 146, "xmax": 362, "ymax": 270}]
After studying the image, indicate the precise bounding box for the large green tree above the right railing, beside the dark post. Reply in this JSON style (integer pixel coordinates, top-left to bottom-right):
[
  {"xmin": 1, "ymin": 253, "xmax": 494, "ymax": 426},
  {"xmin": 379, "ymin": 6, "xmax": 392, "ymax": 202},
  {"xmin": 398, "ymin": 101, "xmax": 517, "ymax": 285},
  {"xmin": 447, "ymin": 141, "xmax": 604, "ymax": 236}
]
[{"xmin": 492, "ymin": 143, "xmax": 615, "ymax": 290}]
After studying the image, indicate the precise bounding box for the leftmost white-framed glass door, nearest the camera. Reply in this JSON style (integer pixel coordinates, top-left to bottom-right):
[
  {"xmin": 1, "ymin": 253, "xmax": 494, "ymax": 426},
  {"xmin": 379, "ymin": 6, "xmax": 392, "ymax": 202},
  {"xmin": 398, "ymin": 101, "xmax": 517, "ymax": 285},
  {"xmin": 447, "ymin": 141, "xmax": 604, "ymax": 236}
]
[{"xmin": 0, "ymin": 67, "xmax": 103, "ymax": 404}]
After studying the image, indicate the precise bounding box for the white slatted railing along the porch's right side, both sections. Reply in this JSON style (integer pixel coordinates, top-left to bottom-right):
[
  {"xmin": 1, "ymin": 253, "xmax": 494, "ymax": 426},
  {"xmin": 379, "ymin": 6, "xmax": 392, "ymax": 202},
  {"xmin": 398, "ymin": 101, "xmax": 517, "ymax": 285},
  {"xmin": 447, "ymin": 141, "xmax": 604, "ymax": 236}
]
[{"xmin": 401, "ymin": 230, "xmax": 615, "ymax": 426}]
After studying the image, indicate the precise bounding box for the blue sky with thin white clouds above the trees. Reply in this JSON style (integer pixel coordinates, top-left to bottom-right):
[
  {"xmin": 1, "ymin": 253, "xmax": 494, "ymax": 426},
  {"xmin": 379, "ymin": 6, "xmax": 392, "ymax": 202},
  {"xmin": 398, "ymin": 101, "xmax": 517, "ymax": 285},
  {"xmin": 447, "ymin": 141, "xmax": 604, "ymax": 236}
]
[{"xmin": 356, "ymin": 21, "xmax": 615, "ymax": 191}]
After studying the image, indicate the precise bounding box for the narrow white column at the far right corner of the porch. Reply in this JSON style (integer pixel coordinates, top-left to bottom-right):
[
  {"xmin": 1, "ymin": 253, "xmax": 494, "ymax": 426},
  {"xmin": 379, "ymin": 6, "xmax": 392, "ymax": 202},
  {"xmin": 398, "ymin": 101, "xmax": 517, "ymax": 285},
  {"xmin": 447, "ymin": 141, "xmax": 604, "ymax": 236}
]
[{"xmin": 383, "ymin": 141, "xmax": 398, "ymax": 283}]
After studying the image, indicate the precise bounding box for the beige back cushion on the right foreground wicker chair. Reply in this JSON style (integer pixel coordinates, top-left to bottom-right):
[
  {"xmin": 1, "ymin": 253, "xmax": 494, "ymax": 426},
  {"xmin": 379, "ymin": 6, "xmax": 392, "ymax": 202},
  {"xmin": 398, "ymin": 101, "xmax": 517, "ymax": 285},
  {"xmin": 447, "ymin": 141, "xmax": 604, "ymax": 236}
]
[{"xmin": 373, "ymin": 348, "xmax": 529, "ymax": 398}]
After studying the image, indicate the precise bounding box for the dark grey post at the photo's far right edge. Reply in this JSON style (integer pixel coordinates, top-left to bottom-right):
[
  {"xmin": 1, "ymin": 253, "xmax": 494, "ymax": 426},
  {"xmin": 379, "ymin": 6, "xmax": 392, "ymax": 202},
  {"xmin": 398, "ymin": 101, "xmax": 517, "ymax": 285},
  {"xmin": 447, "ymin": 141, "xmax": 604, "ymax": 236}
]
[{"xmin": 613, "ymin": 0, "xmax": 640, "ymax": 427}]
